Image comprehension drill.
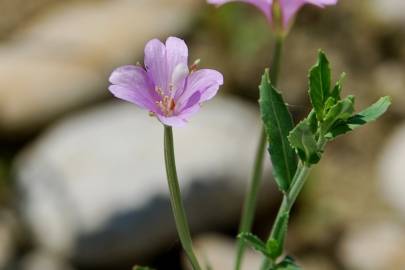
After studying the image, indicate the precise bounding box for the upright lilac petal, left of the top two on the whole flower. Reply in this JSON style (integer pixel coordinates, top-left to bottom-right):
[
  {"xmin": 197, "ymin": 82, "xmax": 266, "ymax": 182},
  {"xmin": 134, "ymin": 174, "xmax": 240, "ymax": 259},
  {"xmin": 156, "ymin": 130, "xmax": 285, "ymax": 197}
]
[{"xmin": 144, "ymin": 39, "xmax": 169, "ymax": 92}]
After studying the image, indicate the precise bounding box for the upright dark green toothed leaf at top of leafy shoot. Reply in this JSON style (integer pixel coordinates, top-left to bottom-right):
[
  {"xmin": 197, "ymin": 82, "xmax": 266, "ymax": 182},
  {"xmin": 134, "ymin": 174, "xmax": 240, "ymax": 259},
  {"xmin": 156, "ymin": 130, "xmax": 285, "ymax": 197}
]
[{"xmin": 309, "ymin": 50, "xmax": 331, "ymax": 121}]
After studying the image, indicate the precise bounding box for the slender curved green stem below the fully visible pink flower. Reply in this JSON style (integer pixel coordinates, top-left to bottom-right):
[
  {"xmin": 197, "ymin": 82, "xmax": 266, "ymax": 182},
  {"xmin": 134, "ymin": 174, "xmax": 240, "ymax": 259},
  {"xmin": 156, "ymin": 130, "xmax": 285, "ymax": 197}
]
[{"xmin": 164, "ymin": 125, "xmax": 201, "ymax": 270}]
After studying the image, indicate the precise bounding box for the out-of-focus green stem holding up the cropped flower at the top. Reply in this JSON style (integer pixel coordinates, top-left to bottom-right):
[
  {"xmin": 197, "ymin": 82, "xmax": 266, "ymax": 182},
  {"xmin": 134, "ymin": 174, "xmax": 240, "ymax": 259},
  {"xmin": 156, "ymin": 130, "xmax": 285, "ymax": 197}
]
[{"xmin": 235, "ymin": 36, "xmax": 284, "ymax": 270}]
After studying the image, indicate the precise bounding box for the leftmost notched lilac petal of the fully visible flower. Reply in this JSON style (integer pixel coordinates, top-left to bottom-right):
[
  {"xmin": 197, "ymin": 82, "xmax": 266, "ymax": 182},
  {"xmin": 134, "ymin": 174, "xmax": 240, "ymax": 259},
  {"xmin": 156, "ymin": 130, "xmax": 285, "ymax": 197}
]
[{"xmin": 108, "ymin": 65, "xmax": 156, "ymax": 111}]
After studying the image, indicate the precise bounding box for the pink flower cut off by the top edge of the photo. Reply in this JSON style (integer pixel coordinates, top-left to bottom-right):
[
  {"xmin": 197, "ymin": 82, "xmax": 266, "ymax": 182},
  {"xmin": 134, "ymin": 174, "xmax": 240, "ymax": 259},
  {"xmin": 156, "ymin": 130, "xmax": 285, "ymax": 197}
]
[{"xmin": 208, "ymin": 0, "xmax": 338, "ymax": 28}]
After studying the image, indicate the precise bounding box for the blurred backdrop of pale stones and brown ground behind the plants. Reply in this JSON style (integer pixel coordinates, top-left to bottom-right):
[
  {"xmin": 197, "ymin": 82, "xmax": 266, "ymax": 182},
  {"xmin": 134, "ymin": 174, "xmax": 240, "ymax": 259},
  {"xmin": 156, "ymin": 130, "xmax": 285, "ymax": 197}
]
[{"xmin": 0, "ymin": 0, "xmax": 405, "ymax": 270}]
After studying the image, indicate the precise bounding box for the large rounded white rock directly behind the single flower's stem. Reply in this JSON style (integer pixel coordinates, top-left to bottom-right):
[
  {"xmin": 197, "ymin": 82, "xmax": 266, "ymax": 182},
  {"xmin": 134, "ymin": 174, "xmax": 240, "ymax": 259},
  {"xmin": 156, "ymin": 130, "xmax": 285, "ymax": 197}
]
[{"xmin": 16, "ymin": 97, "xmax": 270, "ymax": 263}]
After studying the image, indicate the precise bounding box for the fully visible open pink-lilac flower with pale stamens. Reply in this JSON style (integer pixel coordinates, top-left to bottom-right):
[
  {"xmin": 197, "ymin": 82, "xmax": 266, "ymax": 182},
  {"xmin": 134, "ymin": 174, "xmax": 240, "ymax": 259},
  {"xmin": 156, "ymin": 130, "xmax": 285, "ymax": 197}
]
[{"xmin": 109, "ymin": 37, "xmax": 223, "ymax": 127}]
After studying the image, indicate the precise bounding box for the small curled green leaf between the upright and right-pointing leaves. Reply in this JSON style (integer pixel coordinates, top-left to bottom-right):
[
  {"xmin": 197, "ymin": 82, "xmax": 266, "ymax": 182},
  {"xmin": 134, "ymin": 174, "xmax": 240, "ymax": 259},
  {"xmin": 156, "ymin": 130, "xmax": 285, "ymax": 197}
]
[{"xmin": 322, "ymin": 96, "xmax": 354, "ymax": 134}]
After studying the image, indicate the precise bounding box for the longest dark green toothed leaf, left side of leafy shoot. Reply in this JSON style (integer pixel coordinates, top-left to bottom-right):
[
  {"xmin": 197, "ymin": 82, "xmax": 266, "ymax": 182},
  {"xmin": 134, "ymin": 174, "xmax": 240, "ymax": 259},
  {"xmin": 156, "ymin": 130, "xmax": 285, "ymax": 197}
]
[{"xmin": 259, "ymin": 69, "xmax": 298, "ymax": 192}]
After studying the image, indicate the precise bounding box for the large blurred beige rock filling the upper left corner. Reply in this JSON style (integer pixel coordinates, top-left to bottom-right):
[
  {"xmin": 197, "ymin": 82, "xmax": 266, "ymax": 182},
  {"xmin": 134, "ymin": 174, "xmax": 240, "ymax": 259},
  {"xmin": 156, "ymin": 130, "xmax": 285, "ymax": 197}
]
[{"xmin": 0, "ymin": 0, "xmax": 198, "ymax": 132}]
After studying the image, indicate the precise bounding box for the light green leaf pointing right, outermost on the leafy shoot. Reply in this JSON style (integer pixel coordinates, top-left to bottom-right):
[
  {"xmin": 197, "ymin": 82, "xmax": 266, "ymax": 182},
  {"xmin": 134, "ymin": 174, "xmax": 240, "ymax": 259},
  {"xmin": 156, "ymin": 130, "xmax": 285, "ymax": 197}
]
[{"xmin": 326, "ymin": 96, "xmax": 391, "ymax": 139}]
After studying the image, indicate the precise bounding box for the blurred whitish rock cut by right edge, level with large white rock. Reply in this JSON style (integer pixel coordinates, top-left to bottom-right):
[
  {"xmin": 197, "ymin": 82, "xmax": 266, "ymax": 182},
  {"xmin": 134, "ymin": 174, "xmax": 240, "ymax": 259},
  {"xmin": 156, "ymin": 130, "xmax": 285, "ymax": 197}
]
[{"xmin": 379, "ymin": 125, "xmax": 405, "ymax": 220}]
